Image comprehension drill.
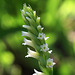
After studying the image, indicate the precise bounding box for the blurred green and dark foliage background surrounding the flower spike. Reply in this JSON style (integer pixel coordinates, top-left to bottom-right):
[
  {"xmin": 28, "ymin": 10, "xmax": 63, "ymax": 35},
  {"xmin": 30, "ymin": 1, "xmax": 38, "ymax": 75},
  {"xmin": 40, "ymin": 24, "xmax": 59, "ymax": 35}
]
[{"xmin": 0, "ymin": 0, "xmax": 75, "ymax": 75}]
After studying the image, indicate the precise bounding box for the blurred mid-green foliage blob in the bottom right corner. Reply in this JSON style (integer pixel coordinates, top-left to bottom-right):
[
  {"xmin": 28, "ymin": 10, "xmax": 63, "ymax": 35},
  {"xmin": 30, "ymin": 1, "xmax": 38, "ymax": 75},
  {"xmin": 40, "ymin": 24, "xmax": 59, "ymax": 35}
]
[{"xmin": 59, "ymin": 59, "xmax": 75, "ymax": 75}]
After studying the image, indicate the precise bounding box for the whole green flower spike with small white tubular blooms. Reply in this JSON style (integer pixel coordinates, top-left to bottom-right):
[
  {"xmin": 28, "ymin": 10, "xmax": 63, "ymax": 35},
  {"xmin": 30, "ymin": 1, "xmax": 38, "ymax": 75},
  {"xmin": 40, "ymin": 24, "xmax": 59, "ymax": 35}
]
[{"xmin": 21, "ymin": 4, "xmax": 55, "ymax": 75}]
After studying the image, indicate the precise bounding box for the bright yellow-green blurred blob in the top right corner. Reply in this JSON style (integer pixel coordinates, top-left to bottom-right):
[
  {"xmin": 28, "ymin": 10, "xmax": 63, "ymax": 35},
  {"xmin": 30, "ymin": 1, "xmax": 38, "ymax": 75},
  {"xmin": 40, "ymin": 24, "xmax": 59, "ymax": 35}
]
[{"xmin": 58, "ymin": 0, "xmax": 75, "ymax": 19}]
